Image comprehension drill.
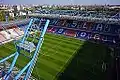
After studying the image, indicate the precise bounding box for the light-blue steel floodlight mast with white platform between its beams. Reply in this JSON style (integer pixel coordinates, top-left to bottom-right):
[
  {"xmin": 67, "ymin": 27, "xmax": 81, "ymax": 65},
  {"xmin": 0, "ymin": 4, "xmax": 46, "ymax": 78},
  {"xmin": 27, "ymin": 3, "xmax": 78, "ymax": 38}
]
[{"xmin": 0, "ymin": 18, "xmax": 50, "ymax": 80}]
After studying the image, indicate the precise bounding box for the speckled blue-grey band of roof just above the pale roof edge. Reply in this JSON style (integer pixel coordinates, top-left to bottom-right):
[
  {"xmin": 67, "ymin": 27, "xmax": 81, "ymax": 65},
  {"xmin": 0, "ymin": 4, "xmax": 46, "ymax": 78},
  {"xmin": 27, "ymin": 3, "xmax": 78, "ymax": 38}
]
[{"xmin": 35, "ymin": 10, "xmax": 114, "ymax": 18}]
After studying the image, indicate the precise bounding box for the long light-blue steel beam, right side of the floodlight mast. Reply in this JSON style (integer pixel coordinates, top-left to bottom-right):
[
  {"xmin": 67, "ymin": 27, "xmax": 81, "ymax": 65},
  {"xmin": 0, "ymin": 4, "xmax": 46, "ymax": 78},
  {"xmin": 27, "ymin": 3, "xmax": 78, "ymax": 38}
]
[{"xmin": 24, "ymin": 20, "xmax": 50, "ymax": 80}]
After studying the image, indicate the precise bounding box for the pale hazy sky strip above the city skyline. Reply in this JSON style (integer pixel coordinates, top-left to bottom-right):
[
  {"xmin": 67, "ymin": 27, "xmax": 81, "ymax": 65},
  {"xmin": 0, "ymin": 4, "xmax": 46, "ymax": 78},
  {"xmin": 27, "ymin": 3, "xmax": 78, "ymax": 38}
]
[{"xmin": 0, "ymin": 0, "xmax": 120, "ymax": 5}]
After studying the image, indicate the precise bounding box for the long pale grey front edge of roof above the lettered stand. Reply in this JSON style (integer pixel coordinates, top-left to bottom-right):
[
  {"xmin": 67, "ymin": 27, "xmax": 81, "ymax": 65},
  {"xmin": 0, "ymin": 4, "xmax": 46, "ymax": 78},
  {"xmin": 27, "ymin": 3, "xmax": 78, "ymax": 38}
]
[{"xmin": 28, "ymin": 13, "xmax": 120, "ymax": 24}]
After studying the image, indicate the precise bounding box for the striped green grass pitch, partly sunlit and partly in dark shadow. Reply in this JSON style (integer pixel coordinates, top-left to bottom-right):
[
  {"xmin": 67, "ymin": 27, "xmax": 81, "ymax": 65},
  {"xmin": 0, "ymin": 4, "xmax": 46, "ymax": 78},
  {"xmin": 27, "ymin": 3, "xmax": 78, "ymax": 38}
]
[{"xmin": 0, "ymin": 34, "xmax": 110, "ymax": 80}]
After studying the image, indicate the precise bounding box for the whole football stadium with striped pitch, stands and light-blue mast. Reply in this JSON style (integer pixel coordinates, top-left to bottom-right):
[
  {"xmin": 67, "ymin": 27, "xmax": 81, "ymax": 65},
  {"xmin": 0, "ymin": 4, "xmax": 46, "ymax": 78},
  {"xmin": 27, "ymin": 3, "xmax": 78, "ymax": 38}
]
[{"xmin": 0, "ymin": 5, "xmax": 120, "ymax": 80}]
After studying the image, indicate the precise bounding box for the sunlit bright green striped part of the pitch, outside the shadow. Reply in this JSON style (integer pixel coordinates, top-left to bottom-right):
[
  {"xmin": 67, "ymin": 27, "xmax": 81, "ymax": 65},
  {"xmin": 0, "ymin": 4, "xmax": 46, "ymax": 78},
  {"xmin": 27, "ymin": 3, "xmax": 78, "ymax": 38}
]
[{"xmin": 0, "ymin": 34, "xmax": 83, "ymax": 80}]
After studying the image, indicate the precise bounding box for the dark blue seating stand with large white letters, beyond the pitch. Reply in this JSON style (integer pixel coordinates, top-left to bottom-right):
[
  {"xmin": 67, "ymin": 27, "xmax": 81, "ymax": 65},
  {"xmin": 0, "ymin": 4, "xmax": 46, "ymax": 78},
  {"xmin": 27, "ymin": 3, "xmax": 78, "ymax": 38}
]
[{"xmin": 15, "ymin": 16, "xmax": 120, "ymax": 46}]
